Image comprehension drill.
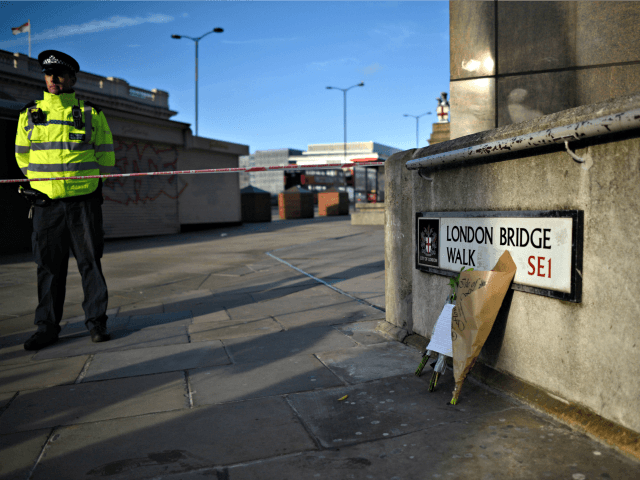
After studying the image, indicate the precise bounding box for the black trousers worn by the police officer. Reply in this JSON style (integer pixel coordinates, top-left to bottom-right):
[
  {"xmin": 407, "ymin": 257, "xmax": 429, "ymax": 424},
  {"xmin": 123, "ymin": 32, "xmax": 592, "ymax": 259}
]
[{"xmin": 31, "ymin": 198, "xmax": 108, "ymax": 335}]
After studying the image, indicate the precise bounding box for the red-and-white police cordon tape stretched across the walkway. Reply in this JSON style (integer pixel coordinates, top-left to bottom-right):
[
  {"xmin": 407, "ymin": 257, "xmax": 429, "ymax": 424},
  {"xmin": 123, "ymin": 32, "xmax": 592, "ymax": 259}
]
[{"xmin": 0, "ymin": 162, "xmax": 384, "ymax": 183}]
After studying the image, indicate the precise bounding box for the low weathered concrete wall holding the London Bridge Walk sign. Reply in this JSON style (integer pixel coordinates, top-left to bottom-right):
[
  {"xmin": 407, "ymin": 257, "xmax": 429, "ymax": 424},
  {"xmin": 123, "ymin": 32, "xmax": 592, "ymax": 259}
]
[{"xmin": 385, "ymin": 94, "xmax": 640, "ymax": 432}]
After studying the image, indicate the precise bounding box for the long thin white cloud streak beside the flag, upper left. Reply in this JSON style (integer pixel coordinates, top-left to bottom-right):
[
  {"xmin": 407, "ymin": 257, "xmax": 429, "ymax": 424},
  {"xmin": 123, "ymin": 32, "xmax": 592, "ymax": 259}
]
[{"xmin": 0, "ymin": 13, "xmax": 173, "ymax": 47}]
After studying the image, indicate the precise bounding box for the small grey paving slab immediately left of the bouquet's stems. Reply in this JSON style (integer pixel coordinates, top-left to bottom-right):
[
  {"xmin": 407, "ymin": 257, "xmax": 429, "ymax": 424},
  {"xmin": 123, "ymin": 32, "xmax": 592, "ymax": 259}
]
[{"xmin": 318, "ymin": 342, "xmax": 422, "ymax": 385}]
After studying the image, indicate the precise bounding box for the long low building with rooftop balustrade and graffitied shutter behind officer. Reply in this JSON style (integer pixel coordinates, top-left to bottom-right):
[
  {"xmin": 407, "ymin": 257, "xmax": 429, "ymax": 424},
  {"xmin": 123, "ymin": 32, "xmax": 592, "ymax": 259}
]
[{"xmin": 0, "ymin": 50, "xmax": 249, "ymax": 251}]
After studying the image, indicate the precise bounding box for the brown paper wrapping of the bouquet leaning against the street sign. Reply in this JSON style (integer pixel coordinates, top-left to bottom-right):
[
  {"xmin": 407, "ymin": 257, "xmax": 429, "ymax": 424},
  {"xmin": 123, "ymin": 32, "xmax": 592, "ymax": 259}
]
[{"xmin": 451, "ymin": 250, "xmax": 516, "ymax": 404}]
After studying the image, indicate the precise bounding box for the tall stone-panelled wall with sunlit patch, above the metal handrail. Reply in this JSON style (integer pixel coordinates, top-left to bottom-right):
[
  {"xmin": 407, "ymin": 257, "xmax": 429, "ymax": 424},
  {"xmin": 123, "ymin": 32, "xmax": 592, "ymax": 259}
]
[{"xmin": 449, "ymin": 1, "xmax": 640, "ymax": 139}]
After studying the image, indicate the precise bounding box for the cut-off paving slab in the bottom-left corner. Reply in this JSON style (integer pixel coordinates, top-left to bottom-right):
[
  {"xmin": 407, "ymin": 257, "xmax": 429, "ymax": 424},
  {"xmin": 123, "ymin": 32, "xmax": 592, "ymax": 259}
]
[{"xmin": 0, "ymin": 428, "xmax": 51, "ymax": 480}]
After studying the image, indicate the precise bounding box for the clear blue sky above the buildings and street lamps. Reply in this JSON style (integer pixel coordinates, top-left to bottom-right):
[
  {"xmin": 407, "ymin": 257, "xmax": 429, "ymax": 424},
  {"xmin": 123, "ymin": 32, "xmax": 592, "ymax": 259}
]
[{"xmin": 0, "ymin": 0, "xmax": 449, "ymax": 152}]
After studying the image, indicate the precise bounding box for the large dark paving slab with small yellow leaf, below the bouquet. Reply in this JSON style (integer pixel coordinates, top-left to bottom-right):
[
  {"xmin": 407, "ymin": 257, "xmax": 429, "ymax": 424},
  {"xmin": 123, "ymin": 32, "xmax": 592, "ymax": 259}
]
[{"xmin": 287, "ymin": 375, "xmax": 514, "ymax": 448}]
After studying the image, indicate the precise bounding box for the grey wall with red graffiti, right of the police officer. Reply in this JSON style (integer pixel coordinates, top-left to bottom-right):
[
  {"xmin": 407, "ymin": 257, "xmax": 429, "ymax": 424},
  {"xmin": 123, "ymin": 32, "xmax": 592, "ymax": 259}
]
[{"xmin": 103, "ymin": 115, "xmax": 249, "ymax": 238}]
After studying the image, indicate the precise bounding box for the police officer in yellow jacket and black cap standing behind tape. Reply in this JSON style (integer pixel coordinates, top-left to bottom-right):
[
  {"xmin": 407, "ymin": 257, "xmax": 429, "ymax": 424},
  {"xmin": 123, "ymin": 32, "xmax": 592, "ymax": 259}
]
[{"xmin": 16, "ymin": 50, "xmax": 115, "ymax": 350}]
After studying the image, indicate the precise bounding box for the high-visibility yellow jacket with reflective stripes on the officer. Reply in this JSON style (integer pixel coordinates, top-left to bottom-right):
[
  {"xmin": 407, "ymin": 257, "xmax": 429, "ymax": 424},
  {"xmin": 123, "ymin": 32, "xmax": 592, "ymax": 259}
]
[{"xmin": 16, "ymin": 91, "xmax": 116, "ymax": 199}]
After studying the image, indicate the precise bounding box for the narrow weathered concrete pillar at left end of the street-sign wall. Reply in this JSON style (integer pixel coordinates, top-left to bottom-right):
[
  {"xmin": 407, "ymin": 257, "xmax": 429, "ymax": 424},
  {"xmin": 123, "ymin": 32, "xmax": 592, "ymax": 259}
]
[{"xmin": 384, "ymin": 150, "xmax": 415, "ymax": 333}]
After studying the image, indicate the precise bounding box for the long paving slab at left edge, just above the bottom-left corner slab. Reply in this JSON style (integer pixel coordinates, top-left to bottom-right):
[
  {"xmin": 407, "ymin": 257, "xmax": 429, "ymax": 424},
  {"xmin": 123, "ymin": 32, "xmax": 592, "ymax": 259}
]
[{"xmin": 0, "ymin": 372, "xmax": 189, "ymax": 434}]
